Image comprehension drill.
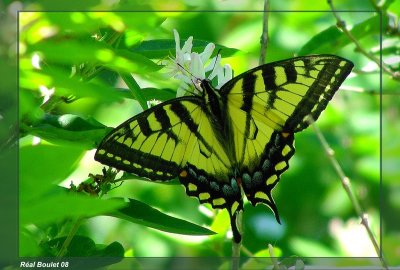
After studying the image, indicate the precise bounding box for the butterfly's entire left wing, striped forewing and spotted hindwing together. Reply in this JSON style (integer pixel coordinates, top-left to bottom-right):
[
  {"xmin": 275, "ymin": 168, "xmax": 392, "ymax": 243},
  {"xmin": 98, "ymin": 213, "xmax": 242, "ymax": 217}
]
[{"xmin": 95, "ymin": 96, "xmax": 243, "ymax": 238}]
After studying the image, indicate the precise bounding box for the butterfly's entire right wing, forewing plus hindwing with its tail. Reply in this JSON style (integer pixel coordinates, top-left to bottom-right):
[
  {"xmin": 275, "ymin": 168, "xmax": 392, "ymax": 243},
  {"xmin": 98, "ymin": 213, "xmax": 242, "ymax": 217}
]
[{"xmin": 220, "ymin": 55, "xmax": 353, "ymax": 217}]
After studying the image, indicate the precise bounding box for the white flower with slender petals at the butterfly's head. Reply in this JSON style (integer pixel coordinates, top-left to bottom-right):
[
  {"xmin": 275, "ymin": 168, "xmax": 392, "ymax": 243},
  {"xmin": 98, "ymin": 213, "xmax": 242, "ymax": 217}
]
[{"xmin": 162, "ymin": 29, "xmax": 232, "ymax": 97}]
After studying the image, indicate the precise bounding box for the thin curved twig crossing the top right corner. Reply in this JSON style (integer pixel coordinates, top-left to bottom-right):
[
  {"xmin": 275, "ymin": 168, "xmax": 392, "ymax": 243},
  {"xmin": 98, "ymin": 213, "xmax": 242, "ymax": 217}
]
[{"xmin": 327, "ymin": 0, "xmax": 400, "ymax": 80}]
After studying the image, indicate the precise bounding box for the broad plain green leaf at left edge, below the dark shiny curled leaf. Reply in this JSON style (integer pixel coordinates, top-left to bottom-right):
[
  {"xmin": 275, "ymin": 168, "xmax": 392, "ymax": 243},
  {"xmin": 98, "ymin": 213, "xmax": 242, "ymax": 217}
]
[{"xmin": 19, "ymin": 144, "xmax": 84, "ymax": 201}]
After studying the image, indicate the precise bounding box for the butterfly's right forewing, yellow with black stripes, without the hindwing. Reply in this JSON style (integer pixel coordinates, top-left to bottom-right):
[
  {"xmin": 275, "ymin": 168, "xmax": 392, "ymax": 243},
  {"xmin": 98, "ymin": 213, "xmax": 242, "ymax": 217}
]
[{"xmin": 221, "ymin": 55, "xmax": 353, "ymax": 132}]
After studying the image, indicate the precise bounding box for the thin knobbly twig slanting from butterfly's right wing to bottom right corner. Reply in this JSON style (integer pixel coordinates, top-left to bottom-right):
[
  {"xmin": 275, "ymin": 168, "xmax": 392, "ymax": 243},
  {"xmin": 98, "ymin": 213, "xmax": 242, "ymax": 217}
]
[{"xmin": 307, "ymin": 116, "xmax": 388, "ymax": 269}]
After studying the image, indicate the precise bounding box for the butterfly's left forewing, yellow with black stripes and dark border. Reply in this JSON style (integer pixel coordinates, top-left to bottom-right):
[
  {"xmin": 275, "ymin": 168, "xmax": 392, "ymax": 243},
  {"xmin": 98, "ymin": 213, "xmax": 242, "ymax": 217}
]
[{"xmin": 95, "ymin": 97, "xmax": 230, "ymax": 181}]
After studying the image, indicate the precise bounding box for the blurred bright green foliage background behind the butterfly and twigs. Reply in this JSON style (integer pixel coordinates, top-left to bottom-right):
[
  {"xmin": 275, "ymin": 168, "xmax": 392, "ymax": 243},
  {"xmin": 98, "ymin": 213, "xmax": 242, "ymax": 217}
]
[{"xmin": 1, "ymin": 0, "xmax": 400, "ymax": 265}]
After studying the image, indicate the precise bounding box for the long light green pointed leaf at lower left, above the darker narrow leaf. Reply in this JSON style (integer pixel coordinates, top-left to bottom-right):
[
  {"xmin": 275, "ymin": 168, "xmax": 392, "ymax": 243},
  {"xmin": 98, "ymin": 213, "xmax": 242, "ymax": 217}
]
[{"xmin": 20, "ymin": 193, "xmax": 124, "ymax": 225}]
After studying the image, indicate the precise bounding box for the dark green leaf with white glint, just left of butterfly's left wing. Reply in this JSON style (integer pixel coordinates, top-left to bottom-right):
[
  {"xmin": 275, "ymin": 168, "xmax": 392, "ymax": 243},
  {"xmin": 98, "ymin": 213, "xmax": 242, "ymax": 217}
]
[{"xmin": 24, "ymin": 114, "xmax": 111, "ymax": 150}]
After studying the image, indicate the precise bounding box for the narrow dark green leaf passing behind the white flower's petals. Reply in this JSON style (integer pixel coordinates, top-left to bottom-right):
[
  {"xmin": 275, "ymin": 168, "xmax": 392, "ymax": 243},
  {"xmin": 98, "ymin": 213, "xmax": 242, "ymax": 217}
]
[{"xmin": 131, "ymin": 39, "xmax": 239, "ymax": 59}]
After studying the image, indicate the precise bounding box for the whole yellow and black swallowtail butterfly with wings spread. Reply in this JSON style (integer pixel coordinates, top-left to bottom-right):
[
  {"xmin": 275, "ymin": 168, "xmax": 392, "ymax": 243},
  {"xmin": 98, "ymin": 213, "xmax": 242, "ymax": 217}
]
[{"xmin": 95, "ymin": 55, "xmax": 353, "ymax": 243}]
